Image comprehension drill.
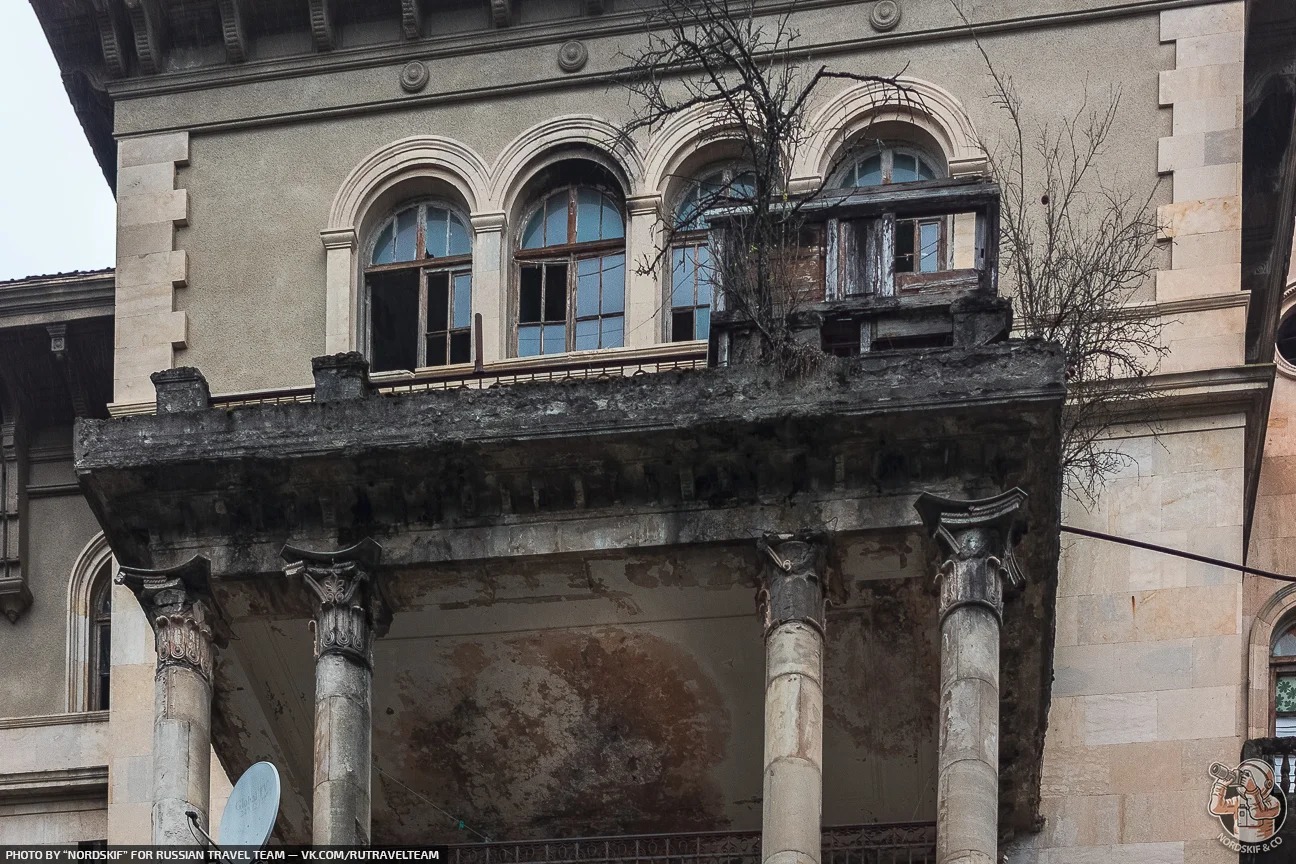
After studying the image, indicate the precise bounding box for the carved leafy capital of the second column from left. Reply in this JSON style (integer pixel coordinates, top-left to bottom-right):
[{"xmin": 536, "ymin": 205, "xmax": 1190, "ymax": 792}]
[{"xmin": 283, "ymin": 539, "xmax": 391, "ymax": 667}]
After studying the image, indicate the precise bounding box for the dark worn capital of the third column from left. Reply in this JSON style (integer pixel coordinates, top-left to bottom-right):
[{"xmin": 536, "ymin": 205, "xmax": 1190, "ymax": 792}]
[{"xmin": 756, "ymin": 534, "xmax": 826, "ymax": 635}]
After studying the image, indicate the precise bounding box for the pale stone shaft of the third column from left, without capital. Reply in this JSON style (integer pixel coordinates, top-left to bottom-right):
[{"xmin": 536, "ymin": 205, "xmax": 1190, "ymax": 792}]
[{"xmin": 761, "ymin": 620, "xmax": 823, "ymax": 864}]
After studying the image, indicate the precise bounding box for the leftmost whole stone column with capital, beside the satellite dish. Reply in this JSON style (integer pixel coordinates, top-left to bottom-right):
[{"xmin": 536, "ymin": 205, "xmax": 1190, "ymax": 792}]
[{"xmin": 117, "ymin": 557, "xmax": 218, "ymax": 846}]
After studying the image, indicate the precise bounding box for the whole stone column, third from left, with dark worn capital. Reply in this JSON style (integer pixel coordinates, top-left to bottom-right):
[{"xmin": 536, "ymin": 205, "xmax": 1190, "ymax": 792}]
[{"xmin": 757, "ymin": 535, "xmax": 824, "ymax": 864}]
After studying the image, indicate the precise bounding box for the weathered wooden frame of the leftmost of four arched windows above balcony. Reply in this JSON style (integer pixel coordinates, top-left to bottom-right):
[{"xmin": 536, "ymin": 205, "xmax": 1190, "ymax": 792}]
[{"xmin": 362, "ymin": 198, "xmax": 476, "ymax": 372}]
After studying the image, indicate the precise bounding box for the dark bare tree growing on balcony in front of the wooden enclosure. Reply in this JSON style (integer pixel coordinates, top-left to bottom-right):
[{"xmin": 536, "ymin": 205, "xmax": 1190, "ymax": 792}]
[{"xmin": 622, "ymin": 0, "xmax": 905, "ymax": 374}]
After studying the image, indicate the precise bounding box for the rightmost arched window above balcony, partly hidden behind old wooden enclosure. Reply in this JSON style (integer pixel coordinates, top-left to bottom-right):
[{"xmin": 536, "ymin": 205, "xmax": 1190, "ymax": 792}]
[{"xmin": 836, "ymin": 144, "xmax": 950, "ymax": 273}]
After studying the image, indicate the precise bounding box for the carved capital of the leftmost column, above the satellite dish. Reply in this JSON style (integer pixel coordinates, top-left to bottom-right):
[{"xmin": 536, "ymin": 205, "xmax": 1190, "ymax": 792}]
[{"xmin": 117, "ymin": 556, "xmax": 219, "ymax": 681}]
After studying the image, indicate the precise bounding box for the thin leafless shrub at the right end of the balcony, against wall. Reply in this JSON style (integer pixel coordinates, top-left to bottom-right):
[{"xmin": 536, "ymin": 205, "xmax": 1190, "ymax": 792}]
[{"xmin": 960, "ymin": 37, "xmax": 1168, "ymax": 504}]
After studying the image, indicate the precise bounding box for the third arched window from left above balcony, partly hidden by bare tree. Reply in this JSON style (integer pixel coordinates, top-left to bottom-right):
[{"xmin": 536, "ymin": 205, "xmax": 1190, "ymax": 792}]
[{"xmin": 669, "ymin": 166, "xmax": 756, "ymax": 342}]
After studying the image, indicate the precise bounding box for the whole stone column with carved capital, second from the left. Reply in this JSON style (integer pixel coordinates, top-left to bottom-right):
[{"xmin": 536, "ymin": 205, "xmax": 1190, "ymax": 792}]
[{"xmin": 283, "ymin": 539, "xmax": 391, "ymax": 846}]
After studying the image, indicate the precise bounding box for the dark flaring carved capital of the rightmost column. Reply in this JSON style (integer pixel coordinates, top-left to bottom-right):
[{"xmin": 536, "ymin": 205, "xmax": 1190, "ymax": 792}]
[{"xmin": 914, "ymin": 488, "xmax": 1028, "ymax": 622}]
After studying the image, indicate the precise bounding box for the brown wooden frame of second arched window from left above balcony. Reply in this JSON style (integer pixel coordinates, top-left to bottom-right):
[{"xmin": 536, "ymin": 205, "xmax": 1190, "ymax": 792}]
[{"xmin": 509, "ymin": 183, "xmax": 630, "ymax": 358}]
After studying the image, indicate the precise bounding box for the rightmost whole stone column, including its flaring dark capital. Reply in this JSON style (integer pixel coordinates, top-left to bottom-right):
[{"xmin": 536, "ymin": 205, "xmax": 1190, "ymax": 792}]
[{"xmin": 915, "ymin": 488, "xmax": 1026, "ymax": 864}]
